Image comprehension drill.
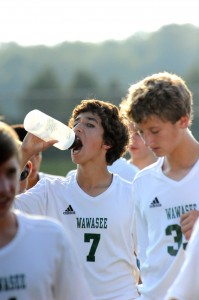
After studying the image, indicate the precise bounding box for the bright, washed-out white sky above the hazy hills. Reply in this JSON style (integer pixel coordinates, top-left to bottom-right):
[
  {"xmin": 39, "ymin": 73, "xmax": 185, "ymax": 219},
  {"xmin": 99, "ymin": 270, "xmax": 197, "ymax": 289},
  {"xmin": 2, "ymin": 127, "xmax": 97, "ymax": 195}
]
[{"xmin": 0, "ymin": 0, "xmax": 199, "ymax": 46}]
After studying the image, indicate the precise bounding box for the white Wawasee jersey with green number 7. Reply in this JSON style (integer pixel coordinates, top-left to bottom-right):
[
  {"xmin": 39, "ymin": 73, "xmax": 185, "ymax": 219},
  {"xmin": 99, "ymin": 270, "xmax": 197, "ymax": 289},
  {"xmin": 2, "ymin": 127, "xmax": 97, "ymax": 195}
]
[{"xmin": 15, "ymin": 174, "xmax": 138, "ymax": 300}]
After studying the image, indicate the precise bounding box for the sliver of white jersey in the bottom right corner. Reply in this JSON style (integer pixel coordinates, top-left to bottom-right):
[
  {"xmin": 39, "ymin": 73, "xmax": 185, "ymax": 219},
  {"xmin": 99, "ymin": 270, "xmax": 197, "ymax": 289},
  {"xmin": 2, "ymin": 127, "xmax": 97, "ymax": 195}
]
[{"xmin": 166, "ymin": 220, "xmax": 199, "ymax": 300}]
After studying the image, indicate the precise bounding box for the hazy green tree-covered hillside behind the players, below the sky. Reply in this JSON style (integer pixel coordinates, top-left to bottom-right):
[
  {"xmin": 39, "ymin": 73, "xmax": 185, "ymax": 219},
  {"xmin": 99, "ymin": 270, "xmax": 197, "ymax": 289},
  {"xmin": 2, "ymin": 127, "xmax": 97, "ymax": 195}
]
[{"xmin": 0, "ymin": 24, "xmax": 199, "ymax": 134}]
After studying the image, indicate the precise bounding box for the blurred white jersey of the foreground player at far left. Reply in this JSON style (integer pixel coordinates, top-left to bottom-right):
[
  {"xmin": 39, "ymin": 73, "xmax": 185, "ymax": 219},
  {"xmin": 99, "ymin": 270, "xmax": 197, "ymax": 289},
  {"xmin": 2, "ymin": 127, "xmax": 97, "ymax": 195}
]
[{"xmin": 0, "ymin": 212, "xmax": 93, "ymax": 300}]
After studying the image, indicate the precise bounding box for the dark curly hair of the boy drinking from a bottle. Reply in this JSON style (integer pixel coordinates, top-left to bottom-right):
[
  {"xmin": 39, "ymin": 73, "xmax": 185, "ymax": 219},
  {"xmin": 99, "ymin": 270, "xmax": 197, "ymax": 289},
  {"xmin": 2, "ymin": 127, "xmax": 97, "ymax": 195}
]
[{"xmin": 68, "ymin": 99, "xmax": 129, "ymax": 165}]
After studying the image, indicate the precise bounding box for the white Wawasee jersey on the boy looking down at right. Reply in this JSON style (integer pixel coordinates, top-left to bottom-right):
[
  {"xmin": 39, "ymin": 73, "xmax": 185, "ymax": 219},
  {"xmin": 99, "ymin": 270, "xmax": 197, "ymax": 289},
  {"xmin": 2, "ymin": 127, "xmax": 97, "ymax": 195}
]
[{"xmin": 133, "ymin": 158, "xmax": 199, "ymax": 300}]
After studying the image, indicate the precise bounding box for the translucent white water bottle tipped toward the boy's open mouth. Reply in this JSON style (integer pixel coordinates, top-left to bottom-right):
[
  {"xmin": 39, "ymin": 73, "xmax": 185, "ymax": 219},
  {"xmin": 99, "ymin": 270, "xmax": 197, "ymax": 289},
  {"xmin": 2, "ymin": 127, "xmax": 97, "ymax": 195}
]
[{"xmin": 24, "ymin": 109, "xmax": 75, "ymax": 150}]
